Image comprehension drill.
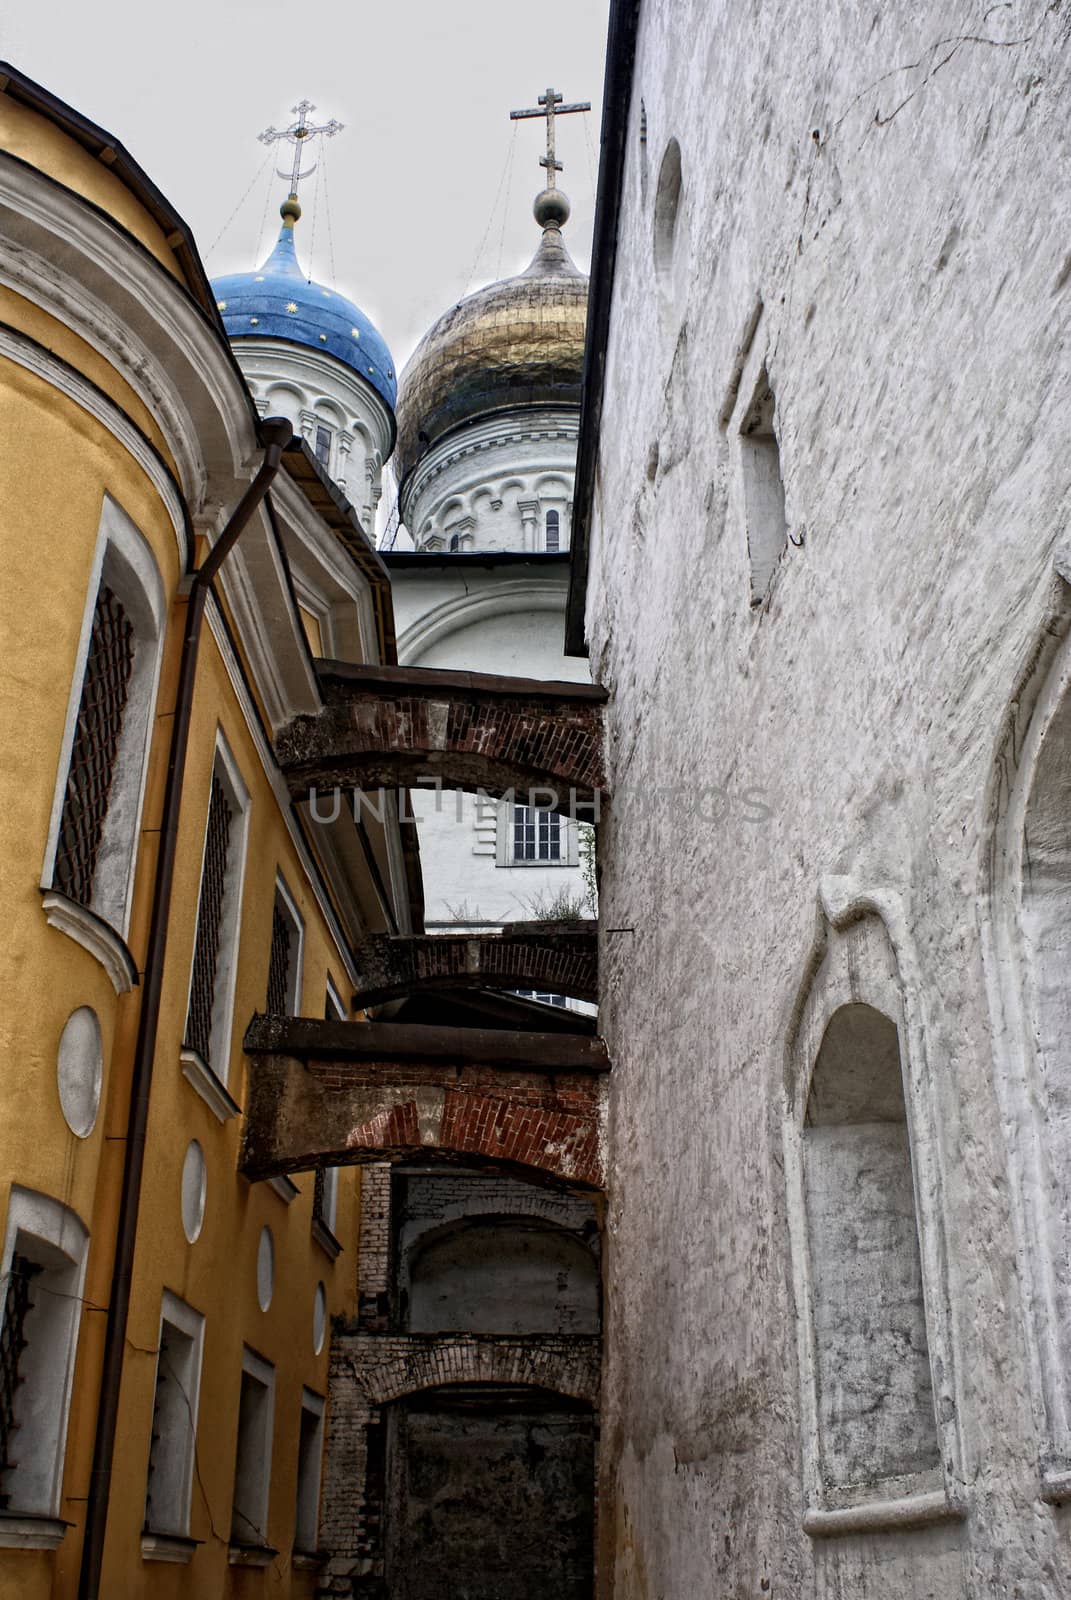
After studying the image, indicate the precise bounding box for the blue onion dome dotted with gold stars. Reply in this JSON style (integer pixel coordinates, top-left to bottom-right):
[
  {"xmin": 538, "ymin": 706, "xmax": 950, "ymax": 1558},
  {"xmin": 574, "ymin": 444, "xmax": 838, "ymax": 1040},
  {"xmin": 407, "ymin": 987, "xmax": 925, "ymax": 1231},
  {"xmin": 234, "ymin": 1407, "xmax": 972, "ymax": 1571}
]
[{"xmin": 213, "ymin": 212, "xmax": 399, "ymax": 411}]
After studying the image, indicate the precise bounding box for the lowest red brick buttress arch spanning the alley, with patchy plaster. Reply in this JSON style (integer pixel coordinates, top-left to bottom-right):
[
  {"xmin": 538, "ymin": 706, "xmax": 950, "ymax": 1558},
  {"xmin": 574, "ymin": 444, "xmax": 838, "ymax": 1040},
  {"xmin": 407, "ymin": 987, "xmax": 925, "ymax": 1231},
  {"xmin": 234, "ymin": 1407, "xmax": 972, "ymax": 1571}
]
[{"xmin": 242, "ymin": 1018, "xmax": 608, "ymax": 1189}]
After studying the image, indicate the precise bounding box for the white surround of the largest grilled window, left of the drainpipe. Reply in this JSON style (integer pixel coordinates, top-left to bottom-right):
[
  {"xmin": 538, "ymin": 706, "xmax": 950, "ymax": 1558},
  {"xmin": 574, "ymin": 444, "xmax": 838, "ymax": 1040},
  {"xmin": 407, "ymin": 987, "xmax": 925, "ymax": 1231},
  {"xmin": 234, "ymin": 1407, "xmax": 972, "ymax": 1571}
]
[{"xmin": 40, "ymin": 494, "xmax": 166, "ymax": 972}]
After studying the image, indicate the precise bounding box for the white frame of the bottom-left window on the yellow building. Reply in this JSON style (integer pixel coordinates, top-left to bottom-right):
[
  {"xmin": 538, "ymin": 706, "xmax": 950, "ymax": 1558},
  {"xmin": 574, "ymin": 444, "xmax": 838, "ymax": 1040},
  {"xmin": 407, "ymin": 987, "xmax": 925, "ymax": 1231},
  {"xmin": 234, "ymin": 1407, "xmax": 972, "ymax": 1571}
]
[{"xmin": 0, "ymin": 1184, "xmax": 90, "ymax": 1523}]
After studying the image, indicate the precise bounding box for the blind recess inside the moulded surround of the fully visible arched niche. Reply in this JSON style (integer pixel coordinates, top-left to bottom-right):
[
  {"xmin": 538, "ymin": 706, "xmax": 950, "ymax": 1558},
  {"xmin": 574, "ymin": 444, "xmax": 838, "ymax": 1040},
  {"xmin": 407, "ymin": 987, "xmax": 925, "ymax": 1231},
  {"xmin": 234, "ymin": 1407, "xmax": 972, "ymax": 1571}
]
[{"xmin": 802, "ymin": 1003, "xmax": 940, "ymax": 1490}]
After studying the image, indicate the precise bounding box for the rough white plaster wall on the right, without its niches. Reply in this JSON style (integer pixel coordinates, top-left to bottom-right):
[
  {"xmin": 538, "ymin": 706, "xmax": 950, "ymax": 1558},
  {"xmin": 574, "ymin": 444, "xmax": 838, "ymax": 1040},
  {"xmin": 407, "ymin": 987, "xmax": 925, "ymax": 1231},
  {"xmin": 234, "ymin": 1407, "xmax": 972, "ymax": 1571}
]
[{"xmin": 579, "ymin": 0, "xmax": 1071, "ymax": 1600}]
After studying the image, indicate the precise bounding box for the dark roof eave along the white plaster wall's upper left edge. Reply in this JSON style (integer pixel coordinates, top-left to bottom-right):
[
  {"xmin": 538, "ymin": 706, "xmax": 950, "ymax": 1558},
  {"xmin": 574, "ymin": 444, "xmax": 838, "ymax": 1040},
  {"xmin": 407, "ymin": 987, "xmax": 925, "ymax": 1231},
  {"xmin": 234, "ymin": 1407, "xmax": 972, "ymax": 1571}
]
[{"xmin": 565, "ymin": 0, "xmax": 640, "ymax": 656}]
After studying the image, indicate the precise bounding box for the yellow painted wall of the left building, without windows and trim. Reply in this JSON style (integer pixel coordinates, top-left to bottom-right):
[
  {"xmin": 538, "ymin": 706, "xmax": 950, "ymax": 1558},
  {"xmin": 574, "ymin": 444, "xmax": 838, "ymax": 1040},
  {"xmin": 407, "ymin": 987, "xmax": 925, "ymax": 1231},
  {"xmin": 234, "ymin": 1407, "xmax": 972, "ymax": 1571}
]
[{"xmin": 0, "ymin": 128, "xmax": 360, "ymax": 1600}]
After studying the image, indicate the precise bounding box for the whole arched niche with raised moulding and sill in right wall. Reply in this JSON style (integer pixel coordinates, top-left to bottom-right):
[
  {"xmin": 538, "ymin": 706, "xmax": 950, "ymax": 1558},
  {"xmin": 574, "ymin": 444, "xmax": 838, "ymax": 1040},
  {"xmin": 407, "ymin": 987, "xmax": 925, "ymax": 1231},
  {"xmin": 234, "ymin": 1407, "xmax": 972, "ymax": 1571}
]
[{"xmin": 784, "ymin": 880, "xmax": 962, "ymax": 1534}]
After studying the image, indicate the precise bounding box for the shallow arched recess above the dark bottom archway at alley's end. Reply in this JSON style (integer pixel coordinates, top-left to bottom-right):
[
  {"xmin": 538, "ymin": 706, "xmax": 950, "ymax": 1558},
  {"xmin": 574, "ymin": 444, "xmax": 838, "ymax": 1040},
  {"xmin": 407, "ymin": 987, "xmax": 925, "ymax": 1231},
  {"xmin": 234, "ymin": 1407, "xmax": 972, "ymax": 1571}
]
[{"xmin": 402, "ymin": 1216, "xmax": 599, "ymax": 1334}]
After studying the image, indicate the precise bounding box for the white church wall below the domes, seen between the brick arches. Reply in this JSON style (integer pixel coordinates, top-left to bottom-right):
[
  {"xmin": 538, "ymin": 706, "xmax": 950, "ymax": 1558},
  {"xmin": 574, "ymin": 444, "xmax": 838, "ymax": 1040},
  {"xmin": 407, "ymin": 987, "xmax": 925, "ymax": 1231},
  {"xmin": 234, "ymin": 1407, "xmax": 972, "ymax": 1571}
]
[{"xmin": 391, "ymin": 560, "xmax": 591, "ymax": 926}]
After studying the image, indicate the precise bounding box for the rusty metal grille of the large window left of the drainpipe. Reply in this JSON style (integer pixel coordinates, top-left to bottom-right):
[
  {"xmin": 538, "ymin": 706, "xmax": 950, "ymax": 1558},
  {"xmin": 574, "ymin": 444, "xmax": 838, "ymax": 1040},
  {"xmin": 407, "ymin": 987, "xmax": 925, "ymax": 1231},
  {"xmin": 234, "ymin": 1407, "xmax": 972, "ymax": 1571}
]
[{"xmin": 53, "ymin": 584, "xmax": 134, "ymax": 907}]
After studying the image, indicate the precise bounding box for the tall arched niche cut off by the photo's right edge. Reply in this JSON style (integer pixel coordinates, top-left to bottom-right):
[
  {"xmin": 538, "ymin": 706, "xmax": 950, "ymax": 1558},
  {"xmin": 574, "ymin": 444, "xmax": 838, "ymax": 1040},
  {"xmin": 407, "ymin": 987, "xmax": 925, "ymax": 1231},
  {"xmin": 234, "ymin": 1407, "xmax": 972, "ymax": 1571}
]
[{"xmin": 983, "ymin": 557, "xmax": 1071, "ymax": 1499}]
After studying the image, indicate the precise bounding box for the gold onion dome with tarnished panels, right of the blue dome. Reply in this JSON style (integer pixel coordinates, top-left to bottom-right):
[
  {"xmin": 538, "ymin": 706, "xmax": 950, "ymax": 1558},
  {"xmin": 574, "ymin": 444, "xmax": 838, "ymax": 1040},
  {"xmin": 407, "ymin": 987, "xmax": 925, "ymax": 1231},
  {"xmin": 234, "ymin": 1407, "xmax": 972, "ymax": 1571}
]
[{"xmin": 395, "ymin": 189, "xmax": 588, "ymax": 478}]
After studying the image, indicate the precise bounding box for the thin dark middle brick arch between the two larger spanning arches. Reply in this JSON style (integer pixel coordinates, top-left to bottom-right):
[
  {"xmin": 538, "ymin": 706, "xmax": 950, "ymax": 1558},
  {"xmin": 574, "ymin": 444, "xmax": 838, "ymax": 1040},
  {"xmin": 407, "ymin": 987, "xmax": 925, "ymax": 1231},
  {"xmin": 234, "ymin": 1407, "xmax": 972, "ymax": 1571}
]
[{"xmin": 354, "ymin": 922, "xmax": 599, "ymax": 1006}]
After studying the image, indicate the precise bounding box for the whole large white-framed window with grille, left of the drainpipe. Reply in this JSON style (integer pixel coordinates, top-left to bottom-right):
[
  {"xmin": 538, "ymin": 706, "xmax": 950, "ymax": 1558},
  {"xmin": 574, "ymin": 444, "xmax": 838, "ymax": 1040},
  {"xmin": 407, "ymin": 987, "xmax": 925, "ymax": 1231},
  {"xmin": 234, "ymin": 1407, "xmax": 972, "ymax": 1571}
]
[{"xmin": 42, "ymin": 496, "xmax": 165, "ymax": 965}]
